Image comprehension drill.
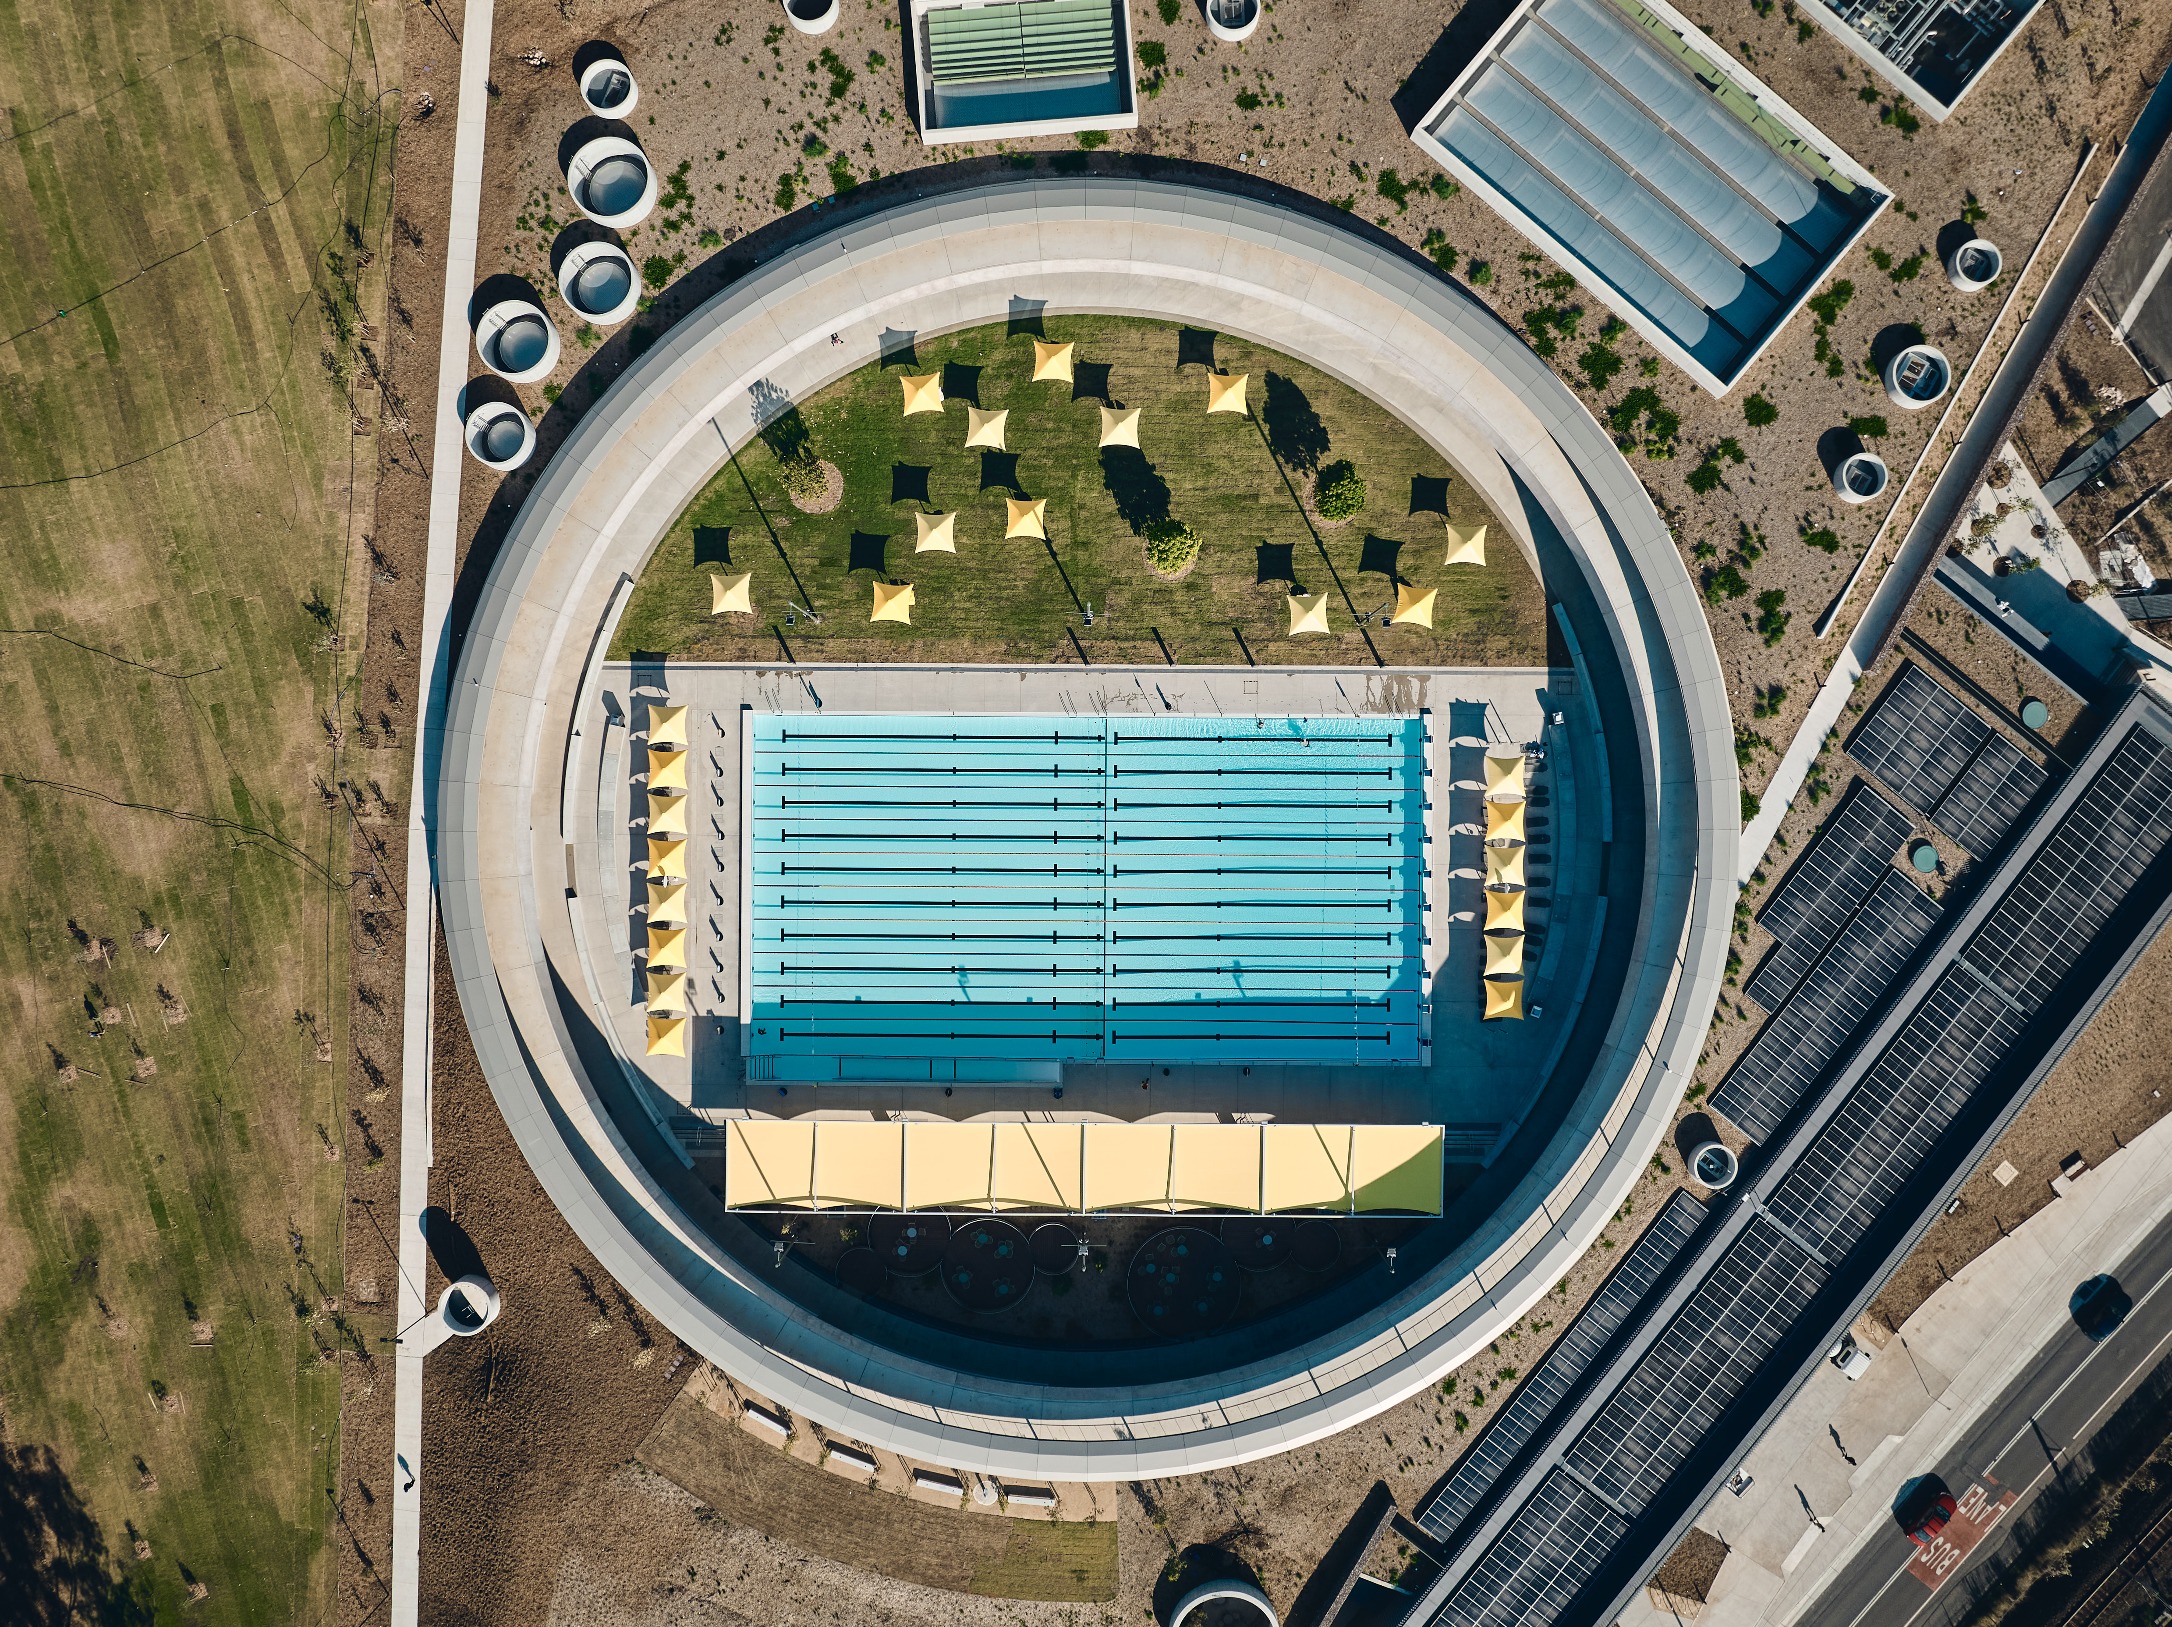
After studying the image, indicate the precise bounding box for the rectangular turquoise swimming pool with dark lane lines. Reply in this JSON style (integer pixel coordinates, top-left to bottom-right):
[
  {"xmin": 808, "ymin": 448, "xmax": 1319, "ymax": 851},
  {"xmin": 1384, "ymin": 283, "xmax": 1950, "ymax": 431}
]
[{"xmin": 741, "ymin": 715, "xmax": 1431, "ymax": 1084}]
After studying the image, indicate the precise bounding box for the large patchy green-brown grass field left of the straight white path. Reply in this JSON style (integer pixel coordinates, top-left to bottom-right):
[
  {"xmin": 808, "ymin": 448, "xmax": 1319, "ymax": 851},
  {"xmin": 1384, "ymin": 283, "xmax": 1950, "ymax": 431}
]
[{"xmin": 0, "ymin": 0, "xmax": 400, "ymax": 1623}]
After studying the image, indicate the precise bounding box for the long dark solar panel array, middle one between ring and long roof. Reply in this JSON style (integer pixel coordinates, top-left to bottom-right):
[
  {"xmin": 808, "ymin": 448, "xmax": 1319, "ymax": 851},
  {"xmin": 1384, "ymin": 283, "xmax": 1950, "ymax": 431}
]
[{"xmin": 1712, "ymin": 865, "xmax": 1942, "ymax": 1140}]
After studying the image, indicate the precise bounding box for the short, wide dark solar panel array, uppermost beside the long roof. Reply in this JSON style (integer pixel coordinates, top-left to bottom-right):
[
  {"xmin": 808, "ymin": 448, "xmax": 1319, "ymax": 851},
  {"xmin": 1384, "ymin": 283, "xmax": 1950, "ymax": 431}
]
[{"xmin": 1848, "ymin": 663, "xmax": 2048, "ymax": 854}]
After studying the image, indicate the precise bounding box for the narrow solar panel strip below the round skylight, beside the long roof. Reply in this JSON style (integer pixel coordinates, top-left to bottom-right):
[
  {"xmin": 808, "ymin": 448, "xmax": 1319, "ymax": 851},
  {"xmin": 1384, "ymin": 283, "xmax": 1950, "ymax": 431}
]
[{"xmin": 1416, "ymin": 1190, "xmax": 1707, "ymax": 1544}]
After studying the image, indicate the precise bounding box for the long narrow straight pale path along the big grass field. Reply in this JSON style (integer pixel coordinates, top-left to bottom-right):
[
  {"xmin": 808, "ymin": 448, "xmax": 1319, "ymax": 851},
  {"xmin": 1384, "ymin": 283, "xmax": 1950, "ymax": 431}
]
[{"xmin": 391, "ymin": 0, "xmax": 493, "ymax": 1627}]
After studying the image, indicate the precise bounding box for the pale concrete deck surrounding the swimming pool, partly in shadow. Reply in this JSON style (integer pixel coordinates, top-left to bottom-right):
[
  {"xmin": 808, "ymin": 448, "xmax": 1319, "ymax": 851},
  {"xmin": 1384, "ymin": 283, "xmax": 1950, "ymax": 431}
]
[{"xmin": 569, "ymin": 663, "xmax": 1603, "ymax": 1162}]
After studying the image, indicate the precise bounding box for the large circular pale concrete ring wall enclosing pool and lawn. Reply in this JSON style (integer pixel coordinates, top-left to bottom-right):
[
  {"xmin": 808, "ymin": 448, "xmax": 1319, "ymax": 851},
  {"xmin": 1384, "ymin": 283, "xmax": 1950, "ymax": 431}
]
[{"xmin": 434, "ymin": 178, "xmax": 1738, "ymax": 1479}]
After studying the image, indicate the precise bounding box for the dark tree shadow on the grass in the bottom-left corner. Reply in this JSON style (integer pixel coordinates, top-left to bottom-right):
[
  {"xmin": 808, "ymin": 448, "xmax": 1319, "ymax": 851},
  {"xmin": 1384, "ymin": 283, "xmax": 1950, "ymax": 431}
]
[{"xmin": 0, "ymin": 1445, "xmax": 152, "ymax": 1627}]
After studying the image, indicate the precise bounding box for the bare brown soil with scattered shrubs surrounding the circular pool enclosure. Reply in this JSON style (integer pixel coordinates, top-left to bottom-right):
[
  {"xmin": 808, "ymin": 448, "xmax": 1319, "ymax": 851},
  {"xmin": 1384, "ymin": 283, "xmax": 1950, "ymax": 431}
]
[{"xmin": 373, "ymin": 0, "xmax": 2172, "ymax": 1623}]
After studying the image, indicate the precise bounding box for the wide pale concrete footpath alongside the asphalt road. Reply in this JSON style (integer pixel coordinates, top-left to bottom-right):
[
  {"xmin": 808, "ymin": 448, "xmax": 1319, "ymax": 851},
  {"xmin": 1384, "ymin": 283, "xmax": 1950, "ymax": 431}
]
[{"xmin": 1622, "ymin": 1117, "xmax": 2172, "ymax": 1627}]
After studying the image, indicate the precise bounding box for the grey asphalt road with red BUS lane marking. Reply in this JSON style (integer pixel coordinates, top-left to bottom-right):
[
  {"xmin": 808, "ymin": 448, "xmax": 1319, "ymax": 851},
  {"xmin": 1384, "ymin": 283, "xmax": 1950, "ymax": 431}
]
[{"xmin": 1803, "ymin": 1190, "xmax": 2172, "ymax": 1627}]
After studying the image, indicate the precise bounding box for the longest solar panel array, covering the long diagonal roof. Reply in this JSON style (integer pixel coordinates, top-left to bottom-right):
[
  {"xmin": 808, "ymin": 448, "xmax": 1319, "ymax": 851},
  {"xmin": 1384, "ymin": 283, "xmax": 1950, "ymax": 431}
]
[{"xmin": 1434, "ymin": 723, "xmax": 2172, "ymax": 1627}]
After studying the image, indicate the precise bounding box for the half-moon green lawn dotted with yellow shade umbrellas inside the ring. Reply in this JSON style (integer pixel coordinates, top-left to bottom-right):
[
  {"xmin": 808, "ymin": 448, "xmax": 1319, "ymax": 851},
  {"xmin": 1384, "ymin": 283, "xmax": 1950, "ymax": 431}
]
[{"xmin": 613, "ymin": 317, "xmax": 1546, "ymax": 665}]
